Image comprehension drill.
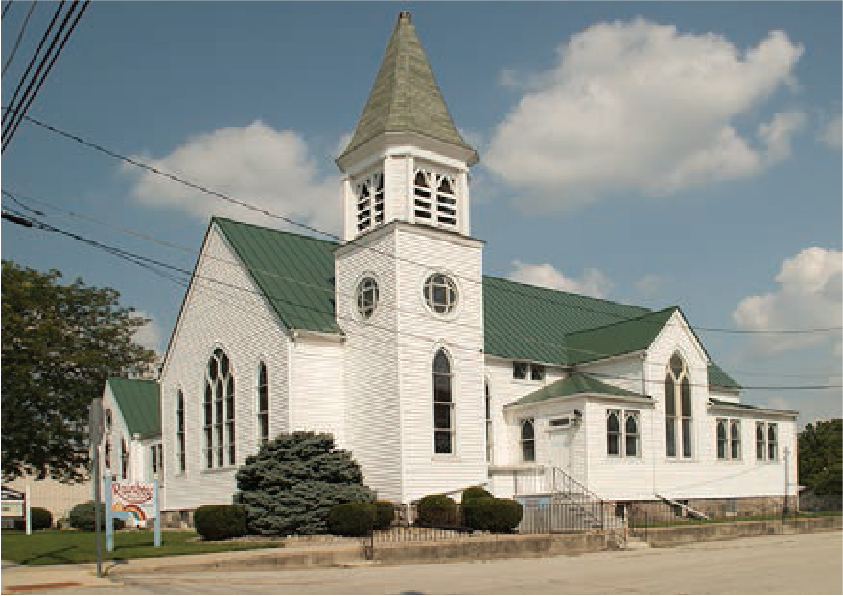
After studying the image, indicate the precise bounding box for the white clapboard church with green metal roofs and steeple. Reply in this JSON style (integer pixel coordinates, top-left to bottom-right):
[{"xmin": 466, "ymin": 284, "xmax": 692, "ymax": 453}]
[{"xmin": 105, "ymin": 13, "xmax": 797, "ymax": 528}]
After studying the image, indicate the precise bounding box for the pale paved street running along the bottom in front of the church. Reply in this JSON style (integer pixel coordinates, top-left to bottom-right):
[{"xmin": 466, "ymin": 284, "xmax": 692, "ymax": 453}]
[{"xmin": 8, "ymin": 532, "xmax": 843, "ymax": 594}]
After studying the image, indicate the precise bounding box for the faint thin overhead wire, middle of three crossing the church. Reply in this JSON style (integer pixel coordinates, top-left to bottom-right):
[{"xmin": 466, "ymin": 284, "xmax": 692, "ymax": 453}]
[{"xmin": 2, "ymin": 189, "xmax": 841, "ymax": 378}]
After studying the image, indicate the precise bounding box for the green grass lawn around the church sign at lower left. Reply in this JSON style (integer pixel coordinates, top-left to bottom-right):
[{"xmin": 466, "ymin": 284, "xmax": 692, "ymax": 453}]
[{"xmin": 2, "ymin": 530, "xmax": 283, "ymax": 565}]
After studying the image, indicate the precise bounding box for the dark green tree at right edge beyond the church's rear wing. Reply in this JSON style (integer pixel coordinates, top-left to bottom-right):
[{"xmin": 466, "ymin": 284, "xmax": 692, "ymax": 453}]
[{"xmin": 797, "ymin": 418, "xmax": 843, "ymax": 495}]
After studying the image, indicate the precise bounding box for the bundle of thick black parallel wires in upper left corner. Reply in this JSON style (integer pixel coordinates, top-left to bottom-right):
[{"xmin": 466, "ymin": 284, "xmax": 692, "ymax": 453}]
[{"xmin": 2, "ymin": 0, "xmax": 90, "ymax": 151}]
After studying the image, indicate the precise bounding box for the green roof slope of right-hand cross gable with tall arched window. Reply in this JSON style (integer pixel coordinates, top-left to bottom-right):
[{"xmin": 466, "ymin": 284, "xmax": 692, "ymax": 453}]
[{"xmin": 566, "ymin": 306, "xmax": 678, "ymax": 364}]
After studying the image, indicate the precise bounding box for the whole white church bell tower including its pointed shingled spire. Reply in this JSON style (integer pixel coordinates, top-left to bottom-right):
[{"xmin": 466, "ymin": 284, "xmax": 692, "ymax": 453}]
[{"xmin": 334, "ymin": 12, "xmax": 487, "ymax": 503}]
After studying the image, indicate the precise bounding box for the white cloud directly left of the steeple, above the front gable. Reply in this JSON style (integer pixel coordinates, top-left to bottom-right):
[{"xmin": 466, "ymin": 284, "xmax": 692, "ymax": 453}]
[{"xmin": 126, "ymin": 121, "xmax": 341, "ymax": 233}]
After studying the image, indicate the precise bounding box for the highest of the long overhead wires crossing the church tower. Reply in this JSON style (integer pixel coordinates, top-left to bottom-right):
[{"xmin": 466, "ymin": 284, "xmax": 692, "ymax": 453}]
[{"xmin": 11, "ymin": 116, "xmax": 843, "ymax": 335}]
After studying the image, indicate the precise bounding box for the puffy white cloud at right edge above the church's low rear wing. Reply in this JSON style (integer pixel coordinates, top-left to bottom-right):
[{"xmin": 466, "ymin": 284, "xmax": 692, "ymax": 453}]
[{"xmin": 733, "ymin": 247, "xmax": 843, "ymax": 354}]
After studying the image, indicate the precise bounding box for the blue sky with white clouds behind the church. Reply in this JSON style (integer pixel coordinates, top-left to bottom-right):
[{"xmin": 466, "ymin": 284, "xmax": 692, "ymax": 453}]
[{"xmin": 2, "ymin": 0, "xmax": 843, "ymax": 422}]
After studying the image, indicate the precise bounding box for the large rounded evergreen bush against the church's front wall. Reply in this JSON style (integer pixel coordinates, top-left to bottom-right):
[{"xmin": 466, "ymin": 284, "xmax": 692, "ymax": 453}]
[{"xmin": 234, "ymin": 431, "xmax": 374, "ymax": 535}]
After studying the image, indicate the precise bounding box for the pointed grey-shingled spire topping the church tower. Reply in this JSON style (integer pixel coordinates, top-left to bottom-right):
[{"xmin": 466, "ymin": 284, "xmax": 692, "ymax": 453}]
[{"xmin": 338, "ymin": 12, "xmax": 477, "ymax": 165}]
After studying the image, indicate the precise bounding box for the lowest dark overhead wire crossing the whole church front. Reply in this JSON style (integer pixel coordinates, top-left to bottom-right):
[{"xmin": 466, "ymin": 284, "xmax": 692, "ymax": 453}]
[{"xmin": 3, "ymin": 209, "xmax": 841, "ymax": 391}]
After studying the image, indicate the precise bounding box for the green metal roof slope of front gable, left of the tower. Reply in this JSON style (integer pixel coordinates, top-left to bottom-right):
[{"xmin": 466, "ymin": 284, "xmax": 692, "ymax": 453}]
[{"xmin": 212, "ymin": 217, "xmax": 342, "ymax": 333}]
